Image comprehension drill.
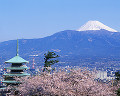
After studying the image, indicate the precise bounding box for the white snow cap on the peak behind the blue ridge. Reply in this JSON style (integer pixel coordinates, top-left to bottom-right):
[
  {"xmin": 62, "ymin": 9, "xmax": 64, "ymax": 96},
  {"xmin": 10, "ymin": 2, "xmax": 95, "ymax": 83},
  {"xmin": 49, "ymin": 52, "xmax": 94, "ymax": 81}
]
[{"xmin": 77, "ymin": 21, "xmax": 118, "ymax": 32}]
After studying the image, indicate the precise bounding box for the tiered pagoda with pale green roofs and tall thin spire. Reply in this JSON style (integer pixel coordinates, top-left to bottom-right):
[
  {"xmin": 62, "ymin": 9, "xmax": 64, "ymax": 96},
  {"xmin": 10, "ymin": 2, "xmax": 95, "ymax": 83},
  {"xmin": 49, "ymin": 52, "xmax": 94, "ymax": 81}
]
[{"xmin": 2, "ymin": 40, "xmax": 30, "ymax": 86}]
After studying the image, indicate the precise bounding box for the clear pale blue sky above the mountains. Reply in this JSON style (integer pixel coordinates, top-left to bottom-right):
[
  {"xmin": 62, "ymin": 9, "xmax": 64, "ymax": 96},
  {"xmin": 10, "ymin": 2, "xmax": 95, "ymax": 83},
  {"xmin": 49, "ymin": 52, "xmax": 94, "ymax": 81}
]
[{"xmin": 0, "ymin": 0, "xmax": 120, "ymax": 42}]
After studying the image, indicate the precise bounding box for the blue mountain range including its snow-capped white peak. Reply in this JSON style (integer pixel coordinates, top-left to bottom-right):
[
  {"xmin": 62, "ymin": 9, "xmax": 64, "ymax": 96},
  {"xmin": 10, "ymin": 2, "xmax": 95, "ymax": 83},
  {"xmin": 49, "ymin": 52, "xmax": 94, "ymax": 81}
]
[{"xmin": 0, "ymin": 21, "xmax": 120, "ymax": 67}]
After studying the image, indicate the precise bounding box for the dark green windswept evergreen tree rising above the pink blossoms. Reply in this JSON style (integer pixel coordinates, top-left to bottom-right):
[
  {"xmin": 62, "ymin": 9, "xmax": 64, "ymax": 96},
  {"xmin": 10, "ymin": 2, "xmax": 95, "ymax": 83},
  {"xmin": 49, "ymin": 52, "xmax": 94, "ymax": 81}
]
[{"xmin": 43, "ymin": 51, "xmax": 59, "ymax": 72}]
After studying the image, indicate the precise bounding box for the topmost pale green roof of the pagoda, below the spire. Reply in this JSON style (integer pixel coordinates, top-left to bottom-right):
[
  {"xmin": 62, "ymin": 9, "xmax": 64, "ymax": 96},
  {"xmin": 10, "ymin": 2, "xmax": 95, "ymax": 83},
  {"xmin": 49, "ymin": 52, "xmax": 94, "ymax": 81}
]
[{"xmin": 5, "ymin": 55, "xmax": 29, "ymax": 63}]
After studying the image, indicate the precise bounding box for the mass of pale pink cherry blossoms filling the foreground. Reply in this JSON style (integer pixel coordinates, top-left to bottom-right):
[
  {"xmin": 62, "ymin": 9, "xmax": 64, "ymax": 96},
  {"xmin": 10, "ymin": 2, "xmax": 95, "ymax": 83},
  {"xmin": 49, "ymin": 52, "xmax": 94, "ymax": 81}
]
[{"xmin": 11, "ymin": 68, "xmax": 117, "ymax": 96}]
